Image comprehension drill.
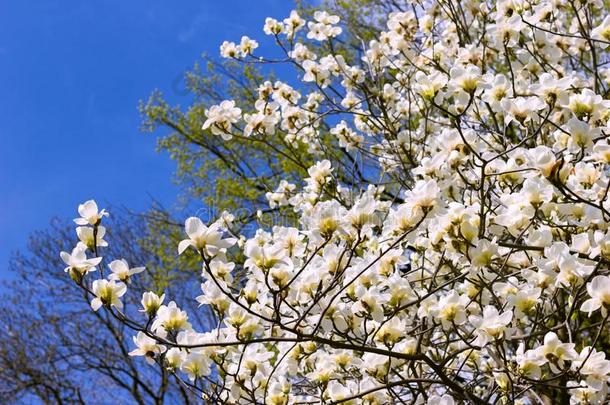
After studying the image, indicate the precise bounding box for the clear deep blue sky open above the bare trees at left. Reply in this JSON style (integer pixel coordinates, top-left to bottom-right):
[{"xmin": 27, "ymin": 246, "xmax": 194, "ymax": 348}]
[{"xmin": 0, "ymin": 0, "xmax": 293, "ymax": 277}]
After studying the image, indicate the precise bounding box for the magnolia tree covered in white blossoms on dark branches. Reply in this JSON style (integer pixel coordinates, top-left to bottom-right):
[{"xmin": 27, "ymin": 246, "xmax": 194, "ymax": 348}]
[{"xmin": 61, "ymin": 0, "xmax": 610, "ymax": 404}]
